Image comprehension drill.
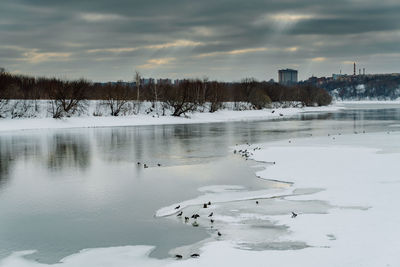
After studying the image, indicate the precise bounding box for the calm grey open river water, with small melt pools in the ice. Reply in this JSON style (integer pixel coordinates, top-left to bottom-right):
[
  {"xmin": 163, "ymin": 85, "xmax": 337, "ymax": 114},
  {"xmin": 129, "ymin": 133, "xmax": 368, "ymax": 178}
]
[{"xmin": 0, "ymin": 105, "xmax": 400, "ymax": 263}]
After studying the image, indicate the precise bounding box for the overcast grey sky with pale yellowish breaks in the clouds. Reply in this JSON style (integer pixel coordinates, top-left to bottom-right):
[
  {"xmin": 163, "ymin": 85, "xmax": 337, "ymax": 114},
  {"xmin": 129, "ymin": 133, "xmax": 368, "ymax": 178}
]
[{"xmin": 0, "ymin": 0, "xmax": 400, "ymax": 82}]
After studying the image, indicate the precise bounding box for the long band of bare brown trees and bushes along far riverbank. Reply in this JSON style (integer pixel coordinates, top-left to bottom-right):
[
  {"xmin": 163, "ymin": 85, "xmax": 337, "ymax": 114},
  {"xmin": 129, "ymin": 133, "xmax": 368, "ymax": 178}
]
[{"xmin": 0, "ymin": 72, "xmax": 331, "ymax": 118}]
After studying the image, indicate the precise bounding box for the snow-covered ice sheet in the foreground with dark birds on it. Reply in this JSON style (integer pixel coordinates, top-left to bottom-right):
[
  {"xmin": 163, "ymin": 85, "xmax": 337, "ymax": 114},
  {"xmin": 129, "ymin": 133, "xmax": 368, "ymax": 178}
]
[{"xmin": 0, "ymin": 132, "xmax": 400, "ymax": 267}]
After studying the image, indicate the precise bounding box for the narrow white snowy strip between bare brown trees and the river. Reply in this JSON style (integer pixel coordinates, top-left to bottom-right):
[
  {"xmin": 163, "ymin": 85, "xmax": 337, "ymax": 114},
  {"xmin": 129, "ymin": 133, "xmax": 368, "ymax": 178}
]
[{"xmin": 0, "ymin": 106, "xmax": 342, "ymax": 132}]
